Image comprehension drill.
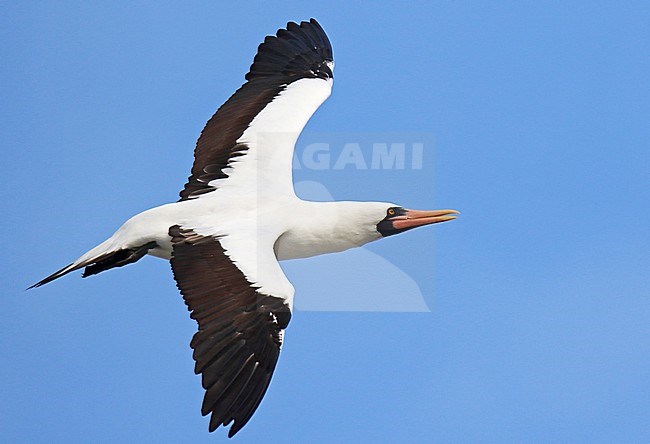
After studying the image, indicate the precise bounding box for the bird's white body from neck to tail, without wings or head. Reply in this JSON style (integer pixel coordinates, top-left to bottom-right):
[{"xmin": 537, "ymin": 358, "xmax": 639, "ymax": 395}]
[{"xmin": 78, "ymin": 195, "xmax": 391, "ymax": 266}]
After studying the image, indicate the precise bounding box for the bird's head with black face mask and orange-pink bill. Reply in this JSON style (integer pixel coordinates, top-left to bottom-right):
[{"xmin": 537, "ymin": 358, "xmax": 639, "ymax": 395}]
[{"xmin": 377, "ymin": 204, "xmax": 459, "ymax": 237}]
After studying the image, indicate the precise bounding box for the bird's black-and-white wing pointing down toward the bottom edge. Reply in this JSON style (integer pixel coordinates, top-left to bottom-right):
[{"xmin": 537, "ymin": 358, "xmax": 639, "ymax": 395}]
[{"xmin": 169, "ymin": 225, "xmax": 293, "ymax": 436}]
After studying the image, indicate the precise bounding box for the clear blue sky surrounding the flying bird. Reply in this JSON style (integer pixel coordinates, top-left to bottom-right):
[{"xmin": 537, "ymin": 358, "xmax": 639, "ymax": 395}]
[{"xmin": 0, "ymin": 1, "xmax": 650, "ymax": 443}]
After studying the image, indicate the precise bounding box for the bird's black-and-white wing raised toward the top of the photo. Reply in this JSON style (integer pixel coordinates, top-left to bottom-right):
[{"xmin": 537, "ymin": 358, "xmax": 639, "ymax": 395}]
[{"xmin": 180, "ymin": 19, "xmax": 334, "ymax": 200}]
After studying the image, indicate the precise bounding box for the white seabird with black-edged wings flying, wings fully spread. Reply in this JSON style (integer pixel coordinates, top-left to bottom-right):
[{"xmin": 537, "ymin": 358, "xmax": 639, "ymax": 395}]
[{"xmin": 30, "ymin": 19, "xmax": 458, "ymax": 437}]
